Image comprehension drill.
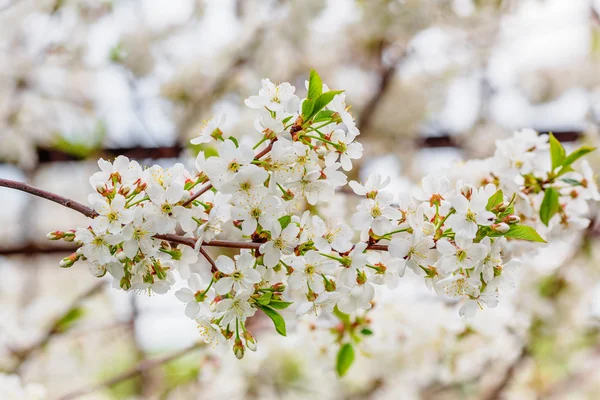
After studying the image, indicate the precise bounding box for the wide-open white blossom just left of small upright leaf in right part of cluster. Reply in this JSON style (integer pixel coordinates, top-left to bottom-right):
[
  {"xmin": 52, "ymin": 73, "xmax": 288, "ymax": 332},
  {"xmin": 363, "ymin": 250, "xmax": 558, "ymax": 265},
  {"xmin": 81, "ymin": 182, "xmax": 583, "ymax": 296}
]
[{"xmin": 446, "ymin": 184, "xmax": 496, "ymax": 239}]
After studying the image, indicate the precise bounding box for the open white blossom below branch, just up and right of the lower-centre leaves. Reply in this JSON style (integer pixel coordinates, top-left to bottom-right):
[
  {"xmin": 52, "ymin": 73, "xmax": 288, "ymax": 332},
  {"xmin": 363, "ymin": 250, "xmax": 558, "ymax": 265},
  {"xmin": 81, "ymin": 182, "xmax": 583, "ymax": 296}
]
[{"xmin": 288, "ymin": 250, "xmax": 337, "ymax": 294}]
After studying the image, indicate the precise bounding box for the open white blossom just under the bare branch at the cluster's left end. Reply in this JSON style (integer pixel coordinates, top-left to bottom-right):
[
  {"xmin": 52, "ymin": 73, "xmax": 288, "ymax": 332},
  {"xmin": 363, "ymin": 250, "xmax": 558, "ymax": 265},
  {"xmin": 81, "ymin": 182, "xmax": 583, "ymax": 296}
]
[{"xmin": 89, "ymin": 193, "xmax": 134, "ymax": 234}]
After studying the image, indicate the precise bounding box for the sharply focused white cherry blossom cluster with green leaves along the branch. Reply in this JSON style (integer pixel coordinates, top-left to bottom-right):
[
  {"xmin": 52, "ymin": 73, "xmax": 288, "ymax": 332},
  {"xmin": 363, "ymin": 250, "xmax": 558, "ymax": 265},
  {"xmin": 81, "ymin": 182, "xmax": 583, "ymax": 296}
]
[{"xmin": 44, "ymin": 71, "xmax": 599, "ymax": 374}]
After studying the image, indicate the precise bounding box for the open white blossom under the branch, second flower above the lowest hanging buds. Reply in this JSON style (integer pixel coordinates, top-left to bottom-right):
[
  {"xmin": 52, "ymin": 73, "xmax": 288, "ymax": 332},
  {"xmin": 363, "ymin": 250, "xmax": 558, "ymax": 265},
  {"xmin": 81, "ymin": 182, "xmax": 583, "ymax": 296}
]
[{"xmin": 215, "ymin": 253, "xmax": 262, "ymax": 295}]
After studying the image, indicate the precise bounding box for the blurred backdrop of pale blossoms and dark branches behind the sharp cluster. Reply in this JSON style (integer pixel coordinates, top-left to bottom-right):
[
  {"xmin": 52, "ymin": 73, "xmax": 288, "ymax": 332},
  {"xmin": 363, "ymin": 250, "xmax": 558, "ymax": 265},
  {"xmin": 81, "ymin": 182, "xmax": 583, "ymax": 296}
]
[{"xmin": 0, "ymin": 0, "xmax": 600, "ymax": 400}]
